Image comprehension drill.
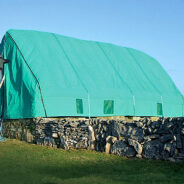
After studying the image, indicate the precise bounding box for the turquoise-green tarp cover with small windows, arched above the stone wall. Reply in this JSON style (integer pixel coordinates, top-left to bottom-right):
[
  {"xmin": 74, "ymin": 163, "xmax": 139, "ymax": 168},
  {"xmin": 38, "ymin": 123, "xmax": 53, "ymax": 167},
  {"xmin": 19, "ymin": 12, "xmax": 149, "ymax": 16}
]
[{"xmin": 0, "ymin": 30, "xmax": 184, "ymax": 119}]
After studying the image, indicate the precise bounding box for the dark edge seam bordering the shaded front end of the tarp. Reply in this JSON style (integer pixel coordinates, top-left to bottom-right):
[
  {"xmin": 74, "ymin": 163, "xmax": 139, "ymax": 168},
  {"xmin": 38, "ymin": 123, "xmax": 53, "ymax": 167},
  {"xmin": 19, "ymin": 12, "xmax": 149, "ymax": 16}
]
[{"xmin": 7, "ymin": 32, "xmax": 47, "ymax": 117}]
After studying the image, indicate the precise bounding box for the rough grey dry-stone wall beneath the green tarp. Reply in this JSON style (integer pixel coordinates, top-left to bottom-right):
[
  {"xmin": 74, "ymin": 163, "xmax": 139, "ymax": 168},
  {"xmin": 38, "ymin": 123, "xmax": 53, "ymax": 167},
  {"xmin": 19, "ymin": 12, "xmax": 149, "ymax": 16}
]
[{"xmin": 3, "ymin": 118, "xmax": 184, "ymax": 161}]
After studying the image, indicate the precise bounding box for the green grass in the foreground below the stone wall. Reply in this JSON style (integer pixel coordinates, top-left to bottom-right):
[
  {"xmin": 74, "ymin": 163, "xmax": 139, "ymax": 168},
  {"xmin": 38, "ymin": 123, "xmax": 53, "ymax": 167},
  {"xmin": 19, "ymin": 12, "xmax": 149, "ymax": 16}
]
[{"xmin": 0, "ymin": 140, "xmax": 184, "ymax": 184}]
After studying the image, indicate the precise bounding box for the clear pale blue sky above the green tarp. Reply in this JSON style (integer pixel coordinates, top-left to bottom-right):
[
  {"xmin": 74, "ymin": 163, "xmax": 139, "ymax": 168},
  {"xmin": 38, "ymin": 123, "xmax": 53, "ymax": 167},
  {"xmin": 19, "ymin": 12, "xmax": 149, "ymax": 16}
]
[{"xmin": 0, "ymin": 0, "xmax": 184, "ymax": 94}]
